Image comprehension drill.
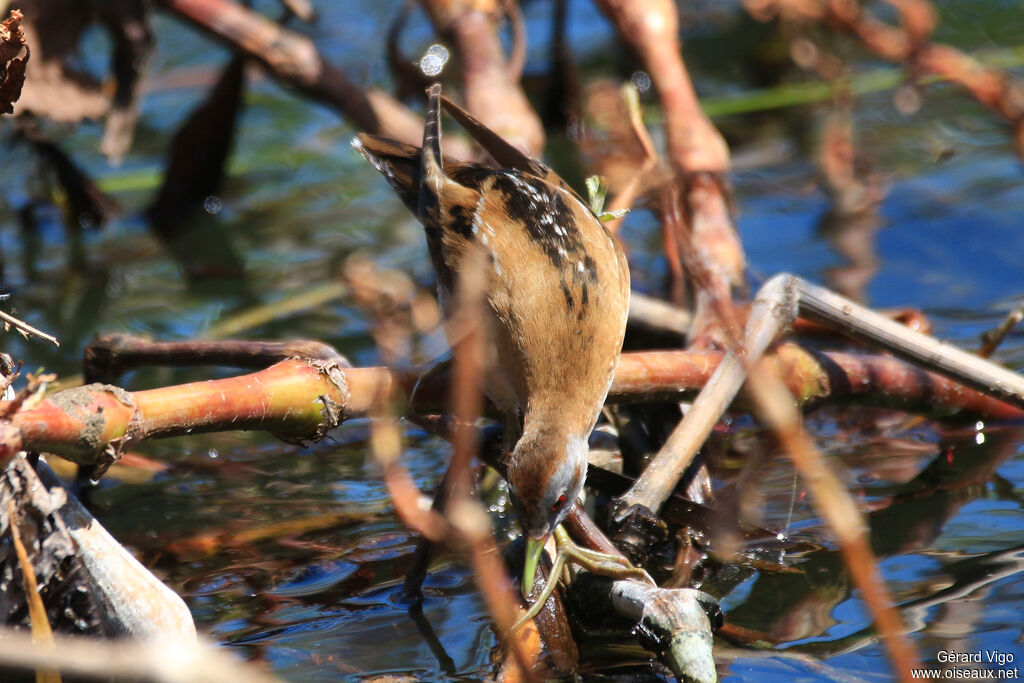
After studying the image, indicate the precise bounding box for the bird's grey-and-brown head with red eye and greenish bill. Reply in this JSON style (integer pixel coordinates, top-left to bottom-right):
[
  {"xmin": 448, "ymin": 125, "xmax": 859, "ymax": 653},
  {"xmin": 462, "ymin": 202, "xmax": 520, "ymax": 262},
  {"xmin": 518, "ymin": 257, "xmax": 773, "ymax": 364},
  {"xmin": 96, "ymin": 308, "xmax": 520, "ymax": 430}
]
[{"xmin": 508, "ymin": 430, "xmax": 588, "ymax": 595}]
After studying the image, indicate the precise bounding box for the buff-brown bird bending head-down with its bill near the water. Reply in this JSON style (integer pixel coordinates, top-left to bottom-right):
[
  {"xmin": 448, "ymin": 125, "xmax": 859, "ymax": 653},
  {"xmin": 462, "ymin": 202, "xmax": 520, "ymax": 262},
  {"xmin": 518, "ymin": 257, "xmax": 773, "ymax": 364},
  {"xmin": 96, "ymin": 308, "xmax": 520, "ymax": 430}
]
[{"xmin": 352, "ymin": 83, "xmax": 630, "ymax": 595}]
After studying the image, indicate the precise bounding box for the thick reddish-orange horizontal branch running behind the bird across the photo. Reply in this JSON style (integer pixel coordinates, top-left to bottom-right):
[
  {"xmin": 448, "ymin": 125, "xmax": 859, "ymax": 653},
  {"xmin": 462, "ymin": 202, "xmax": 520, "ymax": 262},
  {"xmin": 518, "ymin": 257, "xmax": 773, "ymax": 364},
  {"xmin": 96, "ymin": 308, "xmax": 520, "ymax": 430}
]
[{"xmin": 0, "ymin": 344, "xmax": 1024, "ymax": 466}]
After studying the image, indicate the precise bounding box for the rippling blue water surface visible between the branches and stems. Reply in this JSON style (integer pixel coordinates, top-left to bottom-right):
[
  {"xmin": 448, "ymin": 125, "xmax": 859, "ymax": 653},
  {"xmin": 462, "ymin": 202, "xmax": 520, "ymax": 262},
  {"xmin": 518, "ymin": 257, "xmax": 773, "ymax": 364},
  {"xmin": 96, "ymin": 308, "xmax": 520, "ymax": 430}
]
[{"xmin": 0, "ymin": 1, "xmax": 1024, "ymax": 680}]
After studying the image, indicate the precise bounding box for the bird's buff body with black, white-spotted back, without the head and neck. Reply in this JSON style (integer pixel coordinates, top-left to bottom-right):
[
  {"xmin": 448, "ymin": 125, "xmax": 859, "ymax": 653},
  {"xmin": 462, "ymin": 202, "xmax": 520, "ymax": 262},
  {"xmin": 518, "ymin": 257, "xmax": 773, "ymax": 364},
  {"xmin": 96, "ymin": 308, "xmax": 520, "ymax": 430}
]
[{"xmin": 355, "ymin": 88, "xmax": 629, "ymax": 433}]
